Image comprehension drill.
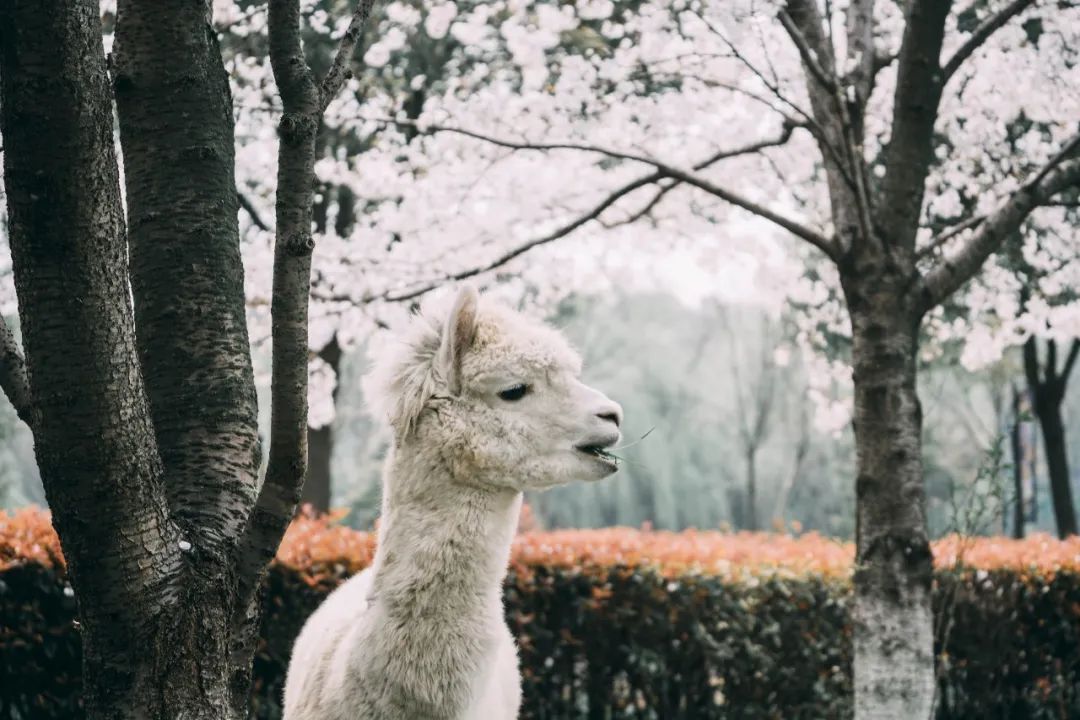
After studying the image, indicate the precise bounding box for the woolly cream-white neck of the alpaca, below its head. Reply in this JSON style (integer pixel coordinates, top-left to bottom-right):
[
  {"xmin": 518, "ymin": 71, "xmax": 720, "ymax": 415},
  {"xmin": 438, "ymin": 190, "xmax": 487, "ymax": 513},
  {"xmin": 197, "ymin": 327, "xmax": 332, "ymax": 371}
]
[{"xmin": 373, "ymin": 448, "xmax": 521, "ymax": 633}]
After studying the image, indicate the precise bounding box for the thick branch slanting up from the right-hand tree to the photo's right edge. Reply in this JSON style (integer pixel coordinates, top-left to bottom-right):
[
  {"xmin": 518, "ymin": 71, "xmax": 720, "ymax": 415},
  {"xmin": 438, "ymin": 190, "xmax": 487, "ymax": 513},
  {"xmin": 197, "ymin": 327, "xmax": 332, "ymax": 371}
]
[{"xmin": 922, "ymin": 133, "xmax": 1080, "ymax": 311}]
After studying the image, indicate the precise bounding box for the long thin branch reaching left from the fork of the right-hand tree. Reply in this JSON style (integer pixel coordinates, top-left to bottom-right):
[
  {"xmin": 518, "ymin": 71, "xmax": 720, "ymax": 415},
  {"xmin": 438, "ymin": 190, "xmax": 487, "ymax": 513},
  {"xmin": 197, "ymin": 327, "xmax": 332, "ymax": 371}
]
[{"xmin": 373, "ymin": 119, "xmax": 838, "ymax": 260}]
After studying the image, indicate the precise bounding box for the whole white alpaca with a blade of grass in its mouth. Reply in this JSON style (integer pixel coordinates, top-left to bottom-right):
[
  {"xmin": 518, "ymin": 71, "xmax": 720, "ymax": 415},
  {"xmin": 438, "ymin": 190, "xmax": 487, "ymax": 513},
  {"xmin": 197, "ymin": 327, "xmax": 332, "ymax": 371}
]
[{"xmin": 285, "ymin": 288, "xmax": 622, "ymax": 720}]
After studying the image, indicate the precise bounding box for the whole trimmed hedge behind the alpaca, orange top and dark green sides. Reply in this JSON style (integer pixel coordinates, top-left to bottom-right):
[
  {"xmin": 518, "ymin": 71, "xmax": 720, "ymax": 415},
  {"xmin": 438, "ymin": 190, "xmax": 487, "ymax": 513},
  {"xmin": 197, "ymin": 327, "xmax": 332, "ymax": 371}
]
[{"xmin": 0, "ymin": 513, "xmax": 1080, "ymax": 720}]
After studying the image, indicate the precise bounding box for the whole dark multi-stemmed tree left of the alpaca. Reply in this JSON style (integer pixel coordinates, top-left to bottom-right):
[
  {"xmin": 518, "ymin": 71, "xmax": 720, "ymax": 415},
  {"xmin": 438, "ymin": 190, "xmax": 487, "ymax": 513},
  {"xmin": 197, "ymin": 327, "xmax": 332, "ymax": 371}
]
[{"xmin": 0, "ymin": 0, "xmax": 373, "ymax": 718}]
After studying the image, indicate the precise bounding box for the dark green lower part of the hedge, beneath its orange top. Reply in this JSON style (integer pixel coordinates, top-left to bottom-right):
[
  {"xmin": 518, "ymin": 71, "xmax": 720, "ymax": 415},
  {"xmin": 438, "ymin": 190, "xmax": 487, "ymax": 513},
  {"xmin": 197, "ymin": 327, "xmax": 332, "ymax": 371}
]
[{"xmin": 0, "ymin": 563, "xmax": 1080, "ymax": 720}]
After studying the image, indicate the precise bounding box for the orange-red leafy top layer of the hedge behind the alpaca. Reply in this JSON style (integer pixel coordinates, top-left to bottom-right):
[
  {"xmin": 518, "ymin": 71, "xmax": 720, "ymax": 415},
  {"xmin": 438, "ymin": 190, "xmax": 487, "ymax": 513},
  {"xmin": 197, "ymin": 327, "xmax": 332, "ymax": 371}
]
[{"xmin": 10, "ymin": 507, "xmax": 1080, "ymax": 582}]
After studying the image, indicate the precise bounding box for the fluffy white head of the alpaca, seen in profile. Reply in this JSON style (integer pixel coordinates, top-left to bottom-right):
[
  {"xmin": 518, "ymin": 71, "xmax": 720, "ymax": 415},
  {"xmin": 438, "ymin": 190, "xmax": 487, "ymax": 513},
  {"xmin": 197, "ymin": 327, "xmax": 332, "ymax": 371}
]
[{"xmin": 365, "ymin": 287, "xmax": 622, "ymax": 490}]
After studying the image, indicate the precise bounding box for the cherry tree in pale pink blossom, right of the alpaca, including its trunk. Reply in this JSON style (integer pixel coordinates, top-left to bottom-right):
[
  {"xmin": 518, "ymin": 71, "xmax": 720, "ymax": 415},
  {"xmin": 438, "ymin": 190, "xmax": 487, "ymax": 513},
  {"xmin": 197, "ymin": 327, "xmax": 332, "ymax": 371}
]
[{"xmin": 272, "ymin": 0, "xmax": 1080, "ymax": 718}]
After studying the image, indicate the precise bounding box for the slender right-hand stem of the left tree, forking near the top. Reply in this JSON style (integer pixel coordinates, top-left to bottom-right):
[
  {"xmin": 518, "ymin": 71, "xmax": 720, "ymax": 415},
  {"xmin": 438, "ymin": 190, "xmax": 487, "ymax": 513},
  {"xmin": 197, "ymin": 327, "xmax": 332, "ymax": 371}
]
[{"xmin": 234, "ymin": 0, "xmax": 373, "ymax": 623}]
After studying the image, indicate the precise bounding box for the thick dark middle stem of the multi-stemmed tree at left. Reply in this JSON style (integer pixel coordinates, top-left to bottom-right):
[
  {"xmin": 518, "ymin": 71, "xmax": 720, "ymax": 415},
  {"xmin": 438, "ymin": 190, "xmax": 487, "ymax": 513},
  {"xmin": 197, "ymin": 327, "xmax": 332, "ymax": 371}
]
[{"xmin": 113, "ymin": 0, "xmax": 259, "ymax": 557}]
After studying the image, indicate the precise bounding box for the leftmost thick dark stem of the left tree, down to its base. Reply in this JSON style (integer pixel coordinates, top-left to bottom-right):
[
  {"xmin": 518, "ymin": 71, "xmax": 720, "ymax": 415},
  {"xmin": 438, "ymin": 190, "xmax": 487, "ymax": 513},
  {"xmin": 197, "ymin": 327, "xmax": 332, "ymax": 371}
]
[{"xmin": 0, "ymin": 0, "xmax": 238, "ymax": 719}]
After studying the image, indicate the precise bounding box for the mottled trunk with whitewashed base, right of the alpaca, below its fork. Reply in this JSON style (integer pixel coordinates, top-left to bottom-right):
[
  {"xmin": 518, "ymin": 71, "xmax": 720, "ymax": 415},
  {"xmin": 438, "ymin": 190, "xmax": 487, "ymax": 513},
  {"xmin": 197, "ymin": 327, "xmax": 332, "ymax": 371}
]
[{"xmin": 841, "ymin": 269, "xmax": 934, "ymax": 720}]
